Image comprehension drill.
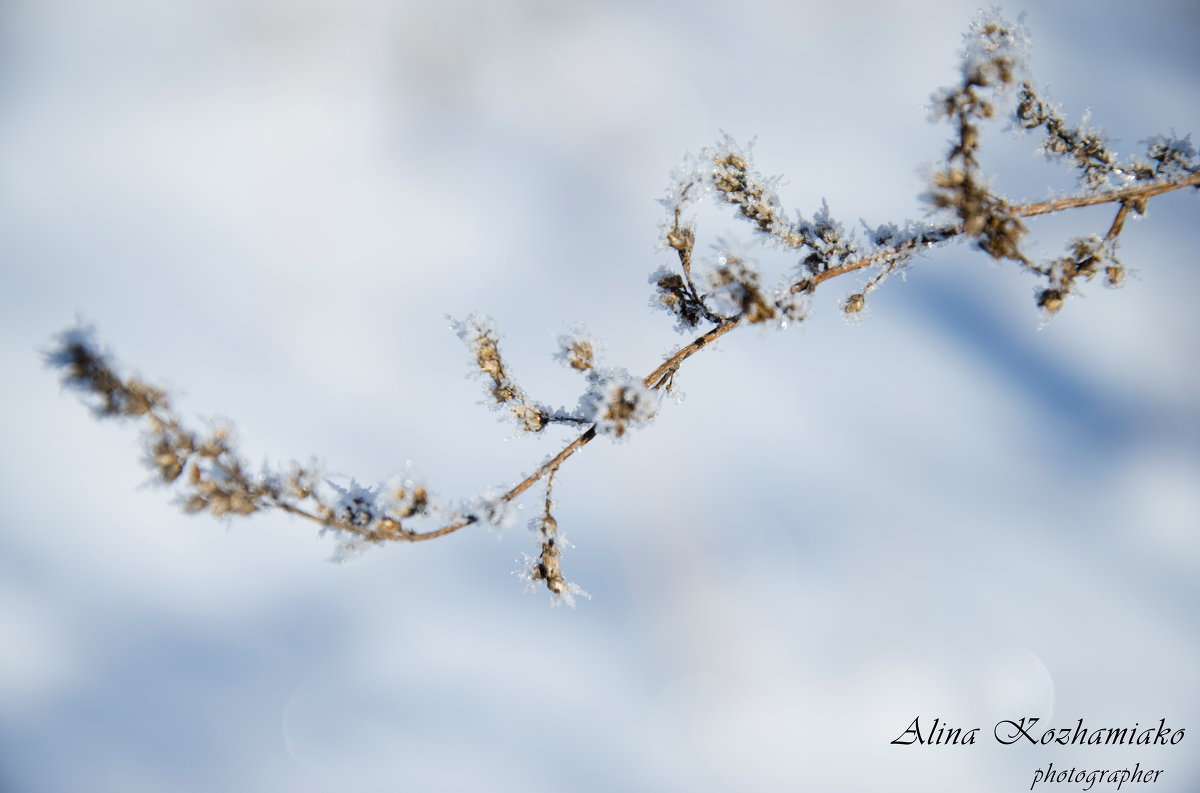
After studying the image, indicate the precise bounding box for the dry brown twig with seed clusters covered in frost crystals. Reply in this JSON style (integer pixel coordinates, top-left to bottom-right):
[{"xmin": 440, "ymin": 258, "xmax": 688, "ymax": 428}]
[{"xmin": 47, "ymin": 9, "xmax": 1200, "ymax": 603}]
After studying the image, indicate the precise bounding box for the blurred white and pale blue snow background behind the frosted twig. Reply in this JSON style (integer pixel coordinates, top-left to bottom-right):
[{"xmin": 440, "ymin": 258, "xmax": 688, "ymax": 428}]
[{"xmin": 0, "ymin": 0, "xmax": 1200, "ymax": 793}]
